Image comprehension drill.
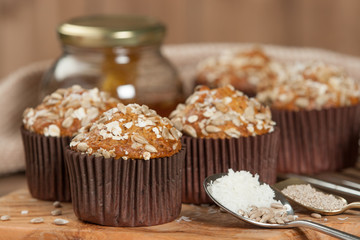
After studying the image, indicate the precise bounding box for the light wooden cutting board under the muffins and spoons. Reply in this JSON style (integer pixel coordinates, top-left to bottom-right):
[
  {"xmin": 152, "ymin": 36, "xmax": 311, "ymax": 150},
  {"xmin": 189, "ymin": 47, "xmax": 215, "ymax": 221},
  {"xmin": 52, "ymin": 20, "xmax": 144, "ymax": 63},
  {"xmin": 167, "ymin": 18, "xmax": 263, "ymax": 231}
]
[{"xmin": 0, "ymin": 189, "xmax": 360, "ymax": 240}]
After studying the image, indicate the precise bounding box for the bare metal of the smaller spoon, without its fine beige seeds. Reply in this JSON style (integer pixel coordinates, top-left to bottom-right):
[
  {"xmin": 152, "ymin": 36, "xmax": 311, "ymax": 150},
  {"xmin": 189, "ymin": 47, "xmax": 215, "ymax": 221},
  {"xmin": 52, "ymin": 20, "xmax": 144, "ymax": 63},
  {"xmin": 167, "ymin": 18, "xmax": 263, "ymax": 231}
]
[{"xmin": 274, "ymin": 178, "xmax": 360, "ymax": 215}]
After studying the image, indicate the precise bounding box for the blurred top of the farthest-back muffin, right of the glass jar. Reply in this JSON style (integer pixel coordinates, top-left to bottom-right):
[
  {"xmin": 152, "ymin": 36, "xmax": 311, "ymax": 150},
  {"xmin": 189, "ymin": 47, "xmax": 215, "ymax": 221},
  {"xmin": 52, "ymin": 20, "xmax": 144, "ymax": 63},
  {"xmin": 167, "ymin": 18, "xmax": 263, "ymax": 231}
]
[{"xmin": 195, "ymin": 48, "xmax": 284, "ymax": 96}]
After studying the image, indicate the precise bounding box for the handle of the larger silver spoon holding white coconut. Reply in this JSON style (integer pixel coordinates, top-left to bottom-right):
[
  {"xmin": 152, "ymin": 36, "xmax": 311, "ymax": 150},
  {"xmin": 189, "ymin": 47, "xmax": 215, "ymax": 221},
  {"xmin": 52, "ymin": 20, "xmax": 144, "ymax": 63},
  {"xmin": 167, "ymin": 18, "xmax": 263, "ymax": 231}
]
[{"xmin": 288, "ymin": 220, "xmax": 360, "ymax": 240}]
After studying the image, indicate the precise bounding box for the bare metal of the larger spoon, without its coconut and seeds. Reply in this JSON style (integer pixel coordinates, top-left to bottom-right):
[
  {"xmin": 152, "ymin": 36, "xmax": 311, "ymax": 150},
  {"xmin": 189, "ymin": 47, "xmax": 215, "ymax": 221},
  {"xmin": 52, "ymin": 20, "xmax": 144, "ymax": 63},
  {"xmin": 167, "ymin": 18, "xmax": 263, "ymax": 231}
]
[{"xmin": 203, "ymin": 173, "xmax": 360, "ymax": 240}]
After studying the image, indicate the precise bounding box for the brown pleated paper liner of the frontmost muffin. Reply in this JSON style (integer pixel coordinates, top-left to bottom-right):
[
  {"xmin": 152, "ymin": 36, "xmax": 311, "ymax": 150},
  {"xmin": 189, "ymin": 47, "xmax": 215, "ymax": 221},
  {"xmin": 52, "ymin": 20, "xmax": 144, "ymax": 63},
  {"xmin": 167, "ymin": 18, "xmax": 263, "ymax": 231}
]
[{"xmin": 66, "ymin": 147, "xmax": 185, "ymax": 227}]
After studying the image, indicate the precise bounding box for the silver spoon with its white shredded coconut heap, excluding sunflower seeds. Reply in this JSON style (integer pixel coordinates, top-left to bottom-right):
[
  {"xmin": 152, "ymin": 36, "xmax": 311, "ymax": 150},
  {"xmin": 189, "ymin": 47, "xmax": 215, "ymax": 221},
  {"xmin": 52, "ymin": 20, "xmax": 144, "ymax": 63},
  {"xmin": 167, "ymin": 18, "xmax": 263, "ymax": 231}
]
[{"xmin": 203, "ymin": 169, "xmax": 359, "ymax": 240}]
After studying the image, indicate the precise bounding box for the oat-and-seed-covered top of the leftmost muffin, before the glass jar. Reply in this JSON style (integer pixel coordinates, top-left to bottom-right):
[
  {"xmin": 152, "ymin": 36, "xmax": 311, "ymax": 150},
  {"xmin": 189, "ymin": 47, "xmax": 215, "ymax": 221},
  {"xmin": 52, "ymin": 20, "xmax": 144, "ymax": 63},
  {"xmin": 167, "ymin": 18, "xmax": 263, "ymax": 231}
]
[{"xmin": 23, "ymin": 85, "xmax": 118, "ymax": 137}]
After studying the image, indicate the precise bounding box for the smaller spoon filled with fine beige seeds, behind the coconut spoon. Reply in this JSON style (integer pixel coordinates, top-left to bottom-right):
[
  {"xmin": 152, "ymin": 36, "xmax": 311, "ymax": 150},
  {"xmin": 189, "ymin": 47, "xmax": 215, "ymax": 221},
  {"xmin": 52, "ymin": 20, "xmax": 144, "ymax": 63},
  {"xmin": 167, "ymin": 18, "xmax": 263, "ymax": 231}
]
[{"xmin": 274, "ymin": 178, "xmax": 360, "ymax": 215}]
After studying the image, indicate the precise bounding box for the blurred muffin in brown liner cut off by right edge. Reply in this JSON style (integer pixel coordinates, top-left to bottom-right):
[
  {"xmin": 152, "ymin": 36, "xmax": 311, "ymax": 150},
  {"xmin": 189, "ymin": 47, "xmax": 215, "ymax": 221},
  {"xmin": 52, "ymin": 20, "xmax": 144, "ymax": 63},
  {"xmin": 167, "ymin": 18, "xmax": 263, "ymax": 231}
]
[{"xmin": 257, "ymin": 62, "xmax": 360, "ymax": 174}]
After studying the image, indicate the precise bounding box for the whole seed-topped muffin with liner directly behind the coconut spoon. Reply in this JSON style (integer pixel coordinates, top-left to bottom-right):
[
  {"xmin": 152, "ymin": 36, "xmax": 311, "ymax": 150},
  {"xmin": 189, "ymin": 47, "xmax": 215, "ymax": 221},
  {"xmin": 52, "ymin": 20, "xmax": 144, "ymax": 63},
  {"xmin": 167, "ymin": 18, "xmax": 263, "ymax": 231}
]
[{"xmin": 170, "ymin": 85, "xmax": 278, "ymax": 204}]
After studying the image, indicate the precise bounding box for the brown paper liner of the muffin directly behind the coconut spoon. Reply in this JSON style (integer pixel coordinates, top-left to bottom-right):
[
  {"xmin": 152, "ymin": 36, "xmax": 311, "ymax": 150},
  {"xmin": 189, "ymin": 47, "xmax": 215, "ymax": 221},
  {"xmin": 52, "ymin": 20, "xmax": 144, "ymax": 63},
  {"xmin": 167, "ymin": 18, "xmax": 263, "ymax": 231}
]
[{"xmin": 182, "ymin": 128, "xmax": 279, "ymax": 204}]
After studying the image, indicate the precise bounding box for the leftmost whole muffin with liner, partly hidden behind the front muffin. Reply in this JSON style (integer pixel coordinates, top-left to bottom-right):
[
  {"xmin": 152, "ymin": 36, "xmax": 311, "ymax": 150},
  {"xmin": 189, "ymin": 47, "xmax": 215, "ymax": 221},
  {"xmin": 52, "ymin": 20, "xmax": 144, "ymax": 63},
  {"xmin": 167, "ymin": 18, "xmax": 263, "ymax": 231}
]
[{"xmin": 21, "ymin": 85, "xmax": 118, "ymax": 201}]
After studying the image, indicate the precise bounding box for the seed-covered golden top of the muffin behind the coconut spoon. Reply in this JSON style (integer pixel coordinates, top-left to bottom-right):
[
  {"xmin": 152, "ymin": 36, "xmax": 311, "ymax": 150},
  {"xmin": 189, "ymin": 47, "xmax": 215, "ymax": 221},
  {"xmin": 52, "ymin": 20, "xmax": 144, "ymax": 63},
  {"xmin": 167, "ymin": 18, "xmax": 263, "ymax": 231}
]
[{"xmin": 170, "ymin": 85, "xmax": 275, "ymax": 138}]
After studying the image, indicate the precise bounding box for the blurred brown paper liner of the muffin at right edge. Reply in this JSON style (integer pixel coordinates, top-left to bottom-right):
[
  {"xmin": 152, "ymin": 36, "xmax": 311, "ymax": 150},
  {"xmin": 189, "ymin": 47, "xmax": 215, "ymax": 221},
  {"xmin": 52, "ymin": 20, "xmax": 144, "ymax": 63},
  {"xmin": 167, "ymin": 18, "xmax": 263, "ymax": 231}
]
[{"xmin": 271, "ymin": 105, "xmax": 360, "ymax": 174}]
